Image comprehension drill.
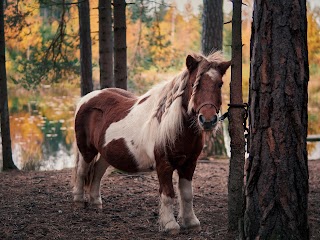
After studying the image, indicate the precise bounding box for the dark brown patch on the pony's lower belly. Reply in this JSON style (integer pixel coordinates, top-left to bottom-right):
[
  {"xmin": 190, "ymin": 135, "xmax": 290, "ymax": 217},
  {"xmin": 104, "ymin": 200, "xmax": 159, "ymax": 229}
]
[{"xmin": 102, "ymin": 138, "xmax": 138, "ymax": 172}]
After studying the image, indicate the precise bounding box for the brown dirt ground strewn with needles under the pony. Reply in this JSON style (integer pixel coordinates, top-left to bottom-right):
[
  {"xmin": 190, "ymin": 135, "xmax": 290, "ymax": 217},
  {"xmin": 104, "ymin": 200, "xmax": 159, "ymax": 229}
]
[{"xmin": 0, "ymin": 160, "xmax": 320, "ymax": 240}]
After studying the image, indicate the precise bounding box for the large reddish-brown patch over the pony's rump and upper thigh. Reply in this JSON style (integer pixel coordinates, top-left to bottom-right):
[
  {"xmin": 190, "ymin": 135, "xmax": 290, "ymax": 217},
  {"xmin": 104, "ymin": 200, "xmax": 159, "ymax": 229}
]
[{"xmin": 75, "ymin": 88, "xmax": 137, "ymax": 163}]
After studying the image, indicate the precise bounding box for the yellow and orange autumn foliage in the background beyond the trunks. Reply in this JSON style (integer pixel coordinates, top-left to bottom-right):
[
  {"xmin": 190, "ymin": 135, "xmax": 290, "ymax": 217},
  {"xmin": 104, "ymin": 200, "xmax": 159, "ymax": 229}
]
[{"xmin": 5, "ymin": 0, "xmax": 320, "ymax": 146}]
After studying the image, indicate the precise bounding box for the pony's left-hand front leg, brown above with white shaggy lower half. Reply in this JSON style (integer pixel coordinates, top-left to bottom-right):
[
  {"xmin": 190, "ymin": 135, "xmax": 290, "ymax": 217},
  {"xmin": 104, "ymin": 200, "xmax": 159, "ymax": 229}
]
[{"xmin": 157, "ymin": 159, "xmax": 180, "ymax": 234}]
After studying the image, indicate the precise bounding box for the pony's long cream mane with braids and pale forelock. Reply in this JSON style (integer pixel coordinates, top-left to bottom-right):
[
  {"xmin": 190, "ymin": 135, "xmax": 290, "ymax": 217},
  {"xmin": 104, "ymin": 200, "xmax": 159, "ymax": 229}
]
[{"xmin": 142, "ymin": 51, "xmax": 224, "ymax": 147}]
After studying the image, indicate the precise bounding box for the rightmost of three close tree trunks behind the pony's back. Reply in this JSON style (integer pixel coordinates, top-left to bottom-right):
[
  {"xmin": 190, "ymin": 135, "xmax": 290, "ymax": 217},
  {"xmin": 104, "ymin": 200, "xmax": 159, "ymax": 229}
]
[{"xmin": 113, "ymin": 0, "xmax": 127, "ymax": 89}]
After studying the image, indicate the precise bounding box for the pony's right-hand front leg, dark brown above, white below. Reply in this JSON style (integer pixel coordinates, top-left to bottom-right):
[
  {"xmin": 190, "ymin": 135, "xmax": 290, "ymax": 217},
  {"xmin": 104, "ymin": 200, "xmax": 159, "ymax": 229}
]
[{"xmin": 178, "ymin": 161, "xmax": 201, "ymax": 231}]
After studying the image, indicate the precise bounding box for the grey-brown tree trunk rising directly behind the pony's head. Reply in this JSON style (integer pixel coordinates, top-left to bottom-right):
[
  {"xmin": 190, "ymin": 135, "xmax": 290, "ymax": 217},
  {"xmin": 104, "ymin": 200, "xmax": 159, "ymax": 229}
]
[{"xmin": 201, "ymin": 0, "xmax": 223, "ymax": 55}]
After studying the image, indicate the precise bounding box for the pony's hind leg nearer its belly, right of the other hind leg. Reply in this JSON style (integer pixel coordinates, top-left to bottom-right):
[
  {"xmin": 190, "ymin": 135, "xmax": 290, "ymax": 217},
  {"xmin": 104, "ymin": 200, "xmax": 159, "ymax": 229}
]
[{"xmin": 90, "ymin": 155, "xmax": 110, "ymax": 208}]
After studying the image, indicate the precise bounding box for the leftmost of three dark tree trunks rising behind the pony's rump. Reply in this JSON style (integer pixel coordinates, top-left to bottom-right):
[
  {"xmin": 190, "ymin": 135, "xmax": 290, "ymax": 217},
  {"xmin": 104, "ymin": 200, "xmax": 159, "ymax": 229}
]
[{"xmin": 78, "ymin": 0, "xmax": 93, "ymax": 96}]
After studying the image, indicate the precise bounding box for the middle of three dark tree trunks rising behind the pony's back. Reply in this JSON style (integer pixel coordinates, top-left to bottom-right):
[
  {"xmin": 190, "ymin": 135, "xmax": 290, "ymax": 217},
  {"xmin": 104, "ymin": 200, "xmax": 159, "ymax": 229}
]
[{"xmin": 99, "ymin": 0, "xmax": 114, "ymax": 89}]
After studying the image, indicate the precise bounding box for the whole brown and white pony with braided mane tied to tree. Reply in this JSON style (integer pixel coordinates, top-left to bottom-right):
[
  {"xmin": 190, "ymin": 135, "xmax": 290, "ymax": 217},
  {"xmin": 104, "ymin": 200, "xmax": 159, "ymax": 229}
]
[{"xmin": 73, "ymin": 52, "xmax": 230, "ymax": 233}]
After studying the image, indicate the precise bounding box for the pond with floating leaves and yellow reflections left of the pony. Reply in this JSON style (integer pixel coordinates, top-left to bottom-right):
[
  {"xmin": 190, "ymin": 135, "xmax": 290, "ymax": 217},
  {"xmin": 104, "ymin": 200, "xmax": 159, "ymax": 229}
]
[{"xmin": 3, "ymin": 85, "xmax": 80, "ymax": 170}]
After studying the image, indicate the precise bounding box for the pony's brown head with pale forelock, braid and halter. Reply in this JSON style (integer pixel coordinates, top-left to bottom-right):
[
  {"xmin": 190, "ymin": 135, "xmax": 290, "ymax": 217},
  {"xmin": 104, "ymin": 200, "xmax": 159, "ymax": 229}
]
[{"xmin": 185, "ymin": 52, "xmax": 231, "ymax": 131}]
